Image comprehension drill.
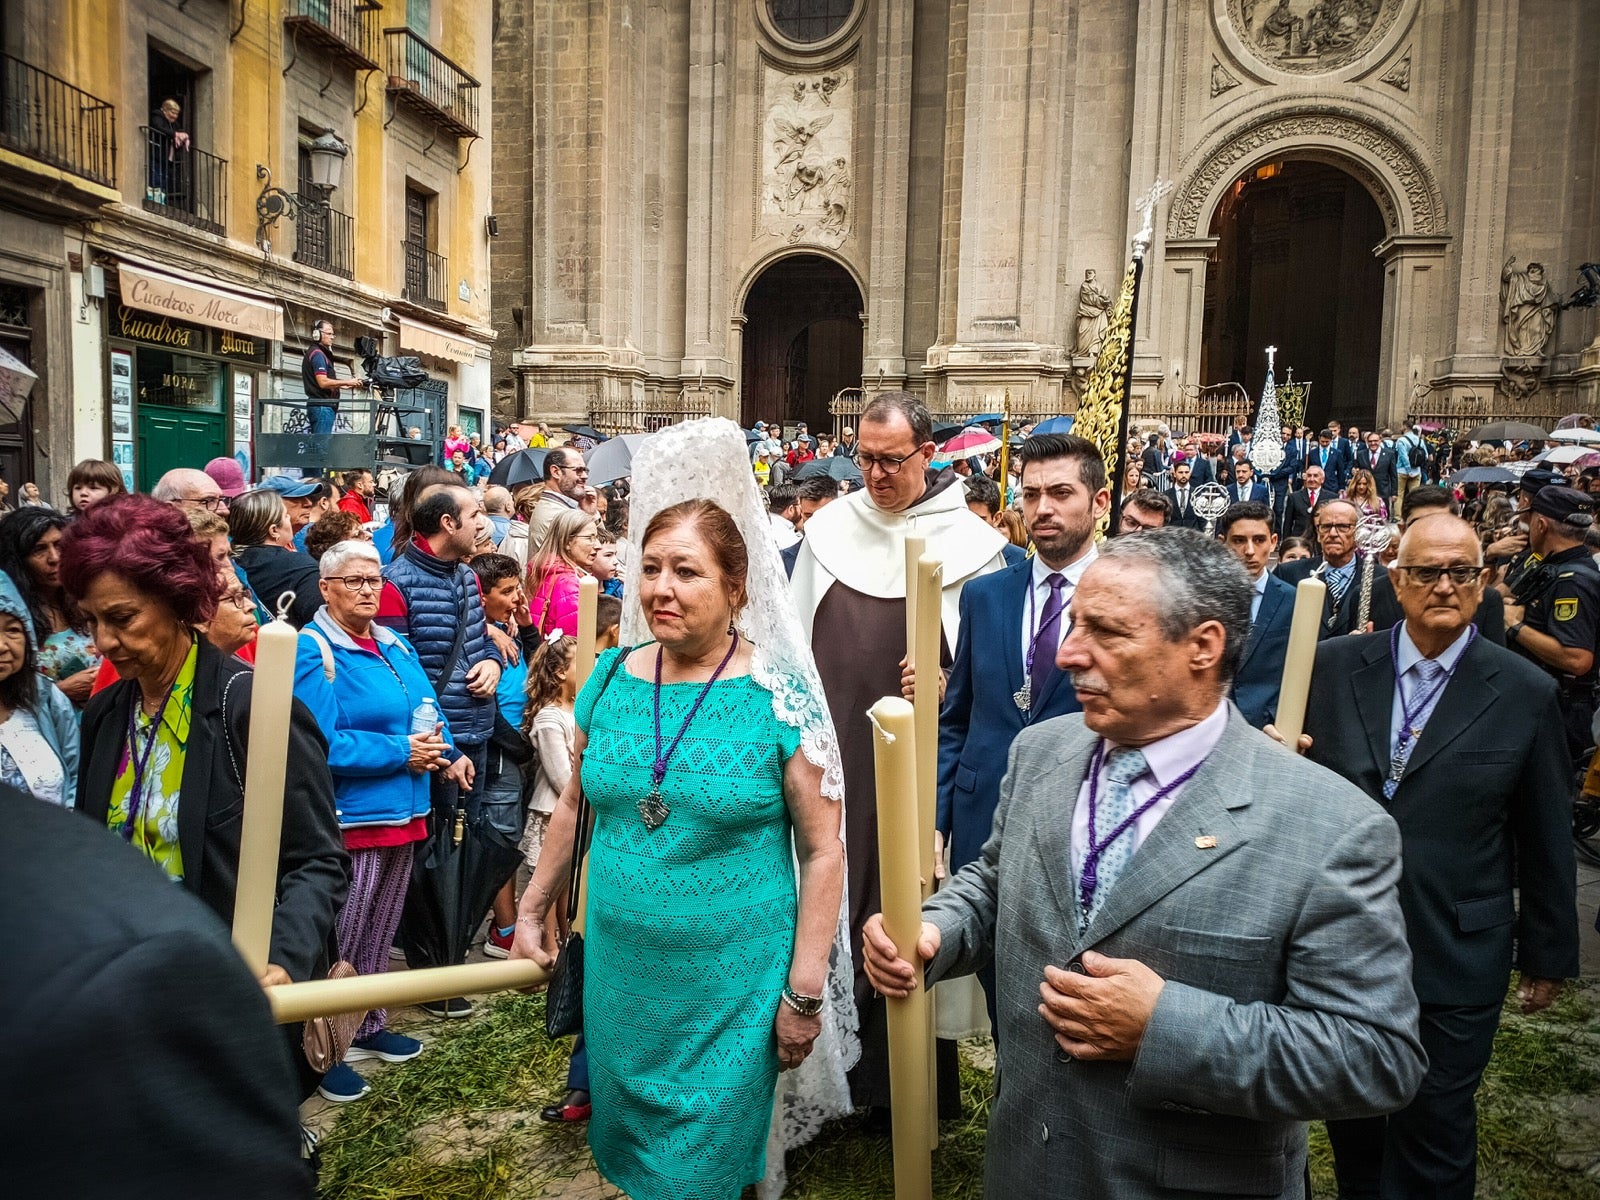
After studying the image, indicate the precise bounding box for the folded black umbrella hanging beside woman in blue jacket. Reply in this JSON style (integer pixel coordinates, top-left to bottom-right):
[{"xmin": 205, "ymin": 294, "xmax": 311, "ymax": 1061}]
[{"xmin": 398, "ymin": 803, "xmax": 522, "ymax": 968}]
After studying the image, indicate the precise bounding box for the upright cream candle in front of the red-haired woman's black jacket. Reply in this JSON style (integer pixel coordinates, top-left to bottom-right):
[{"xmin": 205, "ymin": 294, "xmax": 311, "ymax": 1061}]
[{"xmin": 234, "ymin": 618, "xmax": 299, "ymax": 976}]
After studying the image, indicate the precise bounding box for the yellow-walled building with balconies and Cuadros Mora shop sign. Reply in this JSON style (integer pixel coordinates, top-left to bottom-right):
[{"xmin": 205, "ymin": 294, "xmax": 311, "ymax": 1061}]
[{"xmin": 0, "ymin": 0, "xmax": 493, "ymax": 502}]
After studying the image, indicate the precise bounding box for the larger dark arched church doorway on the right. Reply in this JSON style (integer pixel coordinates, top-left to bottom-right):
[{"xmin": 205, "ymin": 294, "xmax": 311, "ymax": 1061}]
[{"xmin": 1200, "ymin": 158, "xmax": 1387, "ymax": 429}]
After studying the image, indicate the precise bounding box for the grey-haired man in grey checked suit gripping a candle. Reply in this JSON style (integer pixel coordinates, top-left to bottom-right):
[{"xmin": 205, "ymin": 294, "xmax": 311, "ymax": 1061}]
[{"xmin": 864, "ymin": 530, "xmax": 1426, "ymax": 1200}]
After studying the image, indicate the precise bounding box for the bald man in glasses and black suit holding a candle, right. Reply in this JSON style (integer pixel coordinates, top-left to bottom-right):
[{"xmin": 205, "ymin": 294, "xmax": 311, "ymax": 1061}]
[{"xmin": 1306, "ymin": 514, "xmax": 1578, "ymax": 1200}]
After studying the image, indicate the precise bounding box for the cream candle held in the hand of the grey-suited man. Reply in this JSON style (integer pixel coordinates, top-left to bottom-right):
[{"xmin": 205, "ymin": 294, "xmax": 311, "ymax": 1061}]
[{"xmin": 869, "ymin": 696, "xmax": 933, "ymax": 1200}]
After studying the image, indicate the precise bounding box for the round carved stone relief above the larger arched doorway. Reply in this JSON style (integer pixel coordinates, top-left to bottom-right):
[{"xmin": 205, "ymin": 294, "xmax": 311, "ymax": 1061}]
[{"xmin": 1227, "ymin": 0, "xmax": 1402, "ymax": 74}]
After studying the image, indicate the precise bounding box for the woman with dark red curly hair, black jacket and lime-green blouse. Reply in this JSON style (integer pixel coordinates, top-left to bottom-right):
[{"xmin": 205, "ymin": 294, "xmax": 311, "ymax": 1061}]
[{"xmin": 61, "ymin": 496, "xmax": 349, "ymax": 1094}]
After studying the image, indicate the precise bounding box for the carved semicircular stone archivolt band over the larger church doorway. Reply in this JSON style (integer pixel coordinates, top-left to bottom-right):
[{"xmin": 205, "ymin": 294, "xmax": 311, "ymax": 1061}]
[{"xmin": 1166, "ymin": 107, "xmax": 1446, "ymax": 238}]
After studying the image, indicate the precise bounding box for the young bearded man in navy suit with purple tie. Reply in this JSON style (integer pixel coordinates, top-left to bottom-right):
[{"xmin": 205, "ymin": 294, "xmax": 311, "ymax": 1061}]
[{"xmin": 936, "ymin": 434, "xmax": 1110, "ymax": 1019}]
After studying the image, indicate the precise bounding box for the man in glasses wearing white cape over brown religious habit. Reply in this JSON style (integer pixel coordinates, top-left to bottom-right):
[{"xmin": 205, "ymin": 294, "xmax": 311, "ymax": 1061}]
[{"xmin": 792, "ymin": 392, "xmax": 1006, "ymax": 1117}]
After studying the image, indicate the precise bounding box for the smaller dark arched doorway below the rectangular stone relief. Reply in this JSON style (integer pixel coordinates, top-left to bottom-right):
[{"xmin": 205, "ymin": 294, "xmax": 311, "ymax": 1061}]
[{"xmin": 739, "ymin": 254, "xmax": 862, "ymax": 434}]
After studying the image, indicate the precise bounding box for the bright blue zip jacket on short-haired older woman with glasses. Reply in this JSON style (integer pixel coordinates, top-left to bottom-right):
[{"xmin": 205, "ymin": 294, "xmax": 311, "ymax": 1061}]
[{"xmin": 294, "ymin": 605, "xmax": 459, "ymax": 829}]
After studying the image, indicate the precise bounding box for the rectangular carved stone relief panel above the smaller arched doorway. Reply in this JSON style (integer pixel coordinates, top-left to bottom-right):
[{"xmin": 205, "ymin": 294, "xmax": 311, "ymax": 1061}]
[{"xmin": 760, "ymin": 67, "xmax": 856, "ymax": 250}]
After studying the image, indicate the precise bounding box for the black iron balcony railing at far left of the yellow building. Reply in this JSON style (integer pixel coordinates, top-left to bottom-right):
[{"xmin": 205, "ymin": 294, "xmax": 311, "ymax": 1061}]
[{"xmin": 0, "ymin": 54, "xmax": 117, "ymax": 187}]
